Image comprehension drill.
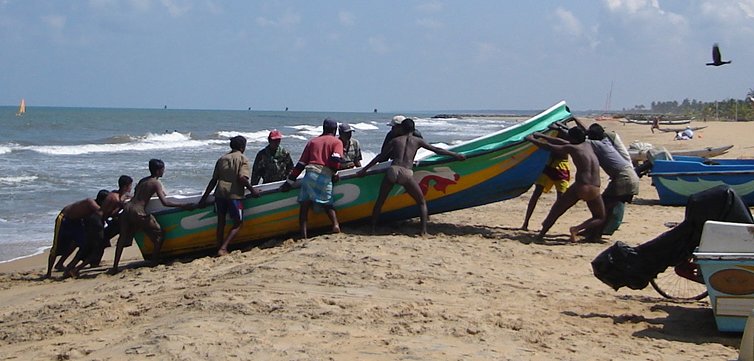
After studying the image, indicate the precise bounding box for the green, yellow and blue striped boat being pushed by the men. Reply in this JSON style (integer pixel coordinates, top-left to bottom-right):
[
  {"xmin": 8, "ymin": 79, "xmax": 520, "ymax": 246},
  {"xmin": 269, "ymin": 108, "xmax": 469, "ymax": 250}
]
[{"xmin": 136, "ymin": 102, "xmax": 571, "ymax": 258}]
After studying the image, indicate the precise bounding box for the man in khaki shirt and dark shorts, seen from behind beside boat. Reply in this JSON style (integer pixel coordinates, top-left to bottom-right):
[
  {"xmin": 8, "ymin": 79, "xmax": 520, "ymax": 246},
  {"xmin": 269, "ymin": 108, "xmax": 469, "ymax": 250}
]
[{"xmin": 199, "ymin": 135, "xmax": 259, "ymax": 256}]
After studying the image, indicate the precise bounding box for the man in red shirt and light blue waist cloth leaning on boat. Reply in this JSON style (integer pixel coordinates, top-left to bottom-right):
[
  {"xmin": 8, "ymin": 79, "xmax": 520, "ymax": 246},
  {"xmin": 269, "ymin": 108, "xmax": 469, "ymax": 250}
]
[{"xmin": 280, "ymin": 118, "xmax": 343, "ymax": 238}]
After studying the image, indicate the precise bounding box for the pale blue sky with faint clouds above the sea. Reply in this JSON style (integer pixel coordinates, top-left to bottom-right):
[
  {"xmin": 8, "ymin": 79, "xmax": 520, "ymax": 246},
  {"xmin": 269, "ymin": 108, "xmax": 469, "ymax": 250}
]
[{"xmin": 0, "ymin": 0, "xmax": 754, "ymax": 111}]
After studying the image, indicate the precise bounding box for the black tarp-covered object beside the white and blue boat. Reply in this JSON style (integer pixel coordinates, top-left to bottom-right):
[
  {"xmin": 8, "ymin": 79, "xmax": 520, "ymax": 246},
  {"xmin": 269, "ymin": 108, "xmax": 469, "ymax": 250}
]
[{"xmin": 592, "ymin": 185, "xmax": 754, "ymax": 290}]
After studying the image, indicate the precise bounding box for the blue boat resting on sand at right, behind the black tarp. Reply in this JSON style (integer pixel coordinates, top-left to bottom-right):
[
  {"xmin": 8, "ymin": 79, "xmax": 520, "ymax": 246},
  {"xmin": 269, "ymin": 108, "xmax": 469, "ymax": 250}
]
[{"xmin": 649, "ymin": 155, "xmax": 754, "ymax": 206}]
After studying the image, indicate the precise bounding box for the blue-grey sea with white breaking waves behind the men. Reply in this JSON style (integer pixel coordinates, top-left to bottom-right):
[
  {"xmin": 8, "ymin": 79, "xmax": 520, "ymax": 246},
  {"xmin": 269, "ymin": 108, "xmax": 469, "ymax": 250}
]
[{"xmin": 0, "ymin": 106, "xmax": 537, "ymax": 262}]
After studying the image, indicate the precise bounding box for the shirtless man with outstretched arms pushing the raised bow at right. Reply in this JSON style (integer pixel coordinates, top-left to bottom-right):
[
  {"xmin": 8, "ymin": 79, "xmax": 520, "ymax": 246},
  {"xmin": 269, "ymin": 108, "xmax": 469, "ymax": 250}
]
[{"xmin": 526, "ymin": 127, "xmax": 605, "ymax": 242}]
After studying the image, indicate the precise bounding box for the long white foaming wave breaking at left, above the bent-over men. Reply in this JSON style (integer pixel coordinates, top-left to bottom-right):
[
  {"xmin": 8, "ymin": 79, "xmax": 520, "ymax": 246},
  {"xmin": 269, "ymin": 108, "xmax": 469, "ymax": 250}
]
[{"xmin": 21, "ymin": 132, "xmax": 210, "ymax": 155}]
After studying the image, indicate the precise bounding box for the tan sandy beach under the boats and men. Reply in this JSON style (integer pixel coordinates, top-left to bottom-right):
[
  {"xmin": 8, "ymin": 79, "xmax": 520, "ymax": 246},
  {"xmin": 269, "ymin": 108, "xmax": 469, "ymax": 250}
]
[{"xmin": 0, "ymin": 119, "xmax": 754, "ymax": 360}]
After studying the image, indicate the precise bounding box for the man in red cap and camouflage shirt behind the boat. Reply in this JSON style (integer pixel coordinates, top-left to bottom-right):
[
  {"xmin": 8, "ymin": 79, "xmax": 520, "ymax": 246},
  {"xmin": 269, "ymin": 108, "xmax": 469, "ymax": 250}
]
[{"xmin": 251, "ymin": 129, "xmax": 293, "ymax": 185}]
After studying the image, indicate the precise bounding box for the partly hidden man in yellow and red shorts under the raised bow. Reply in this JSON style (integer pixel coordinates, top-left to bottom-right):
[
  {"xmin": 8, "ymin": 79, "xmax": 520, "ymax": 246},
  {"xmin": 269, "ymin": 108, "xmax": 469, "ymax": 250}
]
[{"xmin": 521, "ymin": 130, "xmax": 571, "ymax": 231}]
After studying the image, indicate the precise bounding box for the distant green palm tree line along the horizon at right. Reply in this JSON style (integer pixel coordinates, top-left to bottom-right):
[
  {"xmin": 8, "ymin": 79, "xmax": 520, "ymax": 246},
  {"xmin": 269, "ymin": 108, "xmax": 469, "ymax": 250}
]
[{"xmin": 625, "ymin": 89, "xmax": 754, "ymax": 121}]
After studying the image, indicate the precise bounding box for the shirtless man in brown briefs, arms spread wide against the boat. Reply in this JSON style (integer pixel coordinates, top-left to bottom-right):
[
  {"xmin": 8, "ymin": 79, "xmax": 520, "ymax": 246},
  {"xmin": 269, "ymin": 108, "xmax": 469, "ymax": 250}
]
[{"xmin": 357, "ymin": 118, "xmax": 466, "ymax": 236}]
